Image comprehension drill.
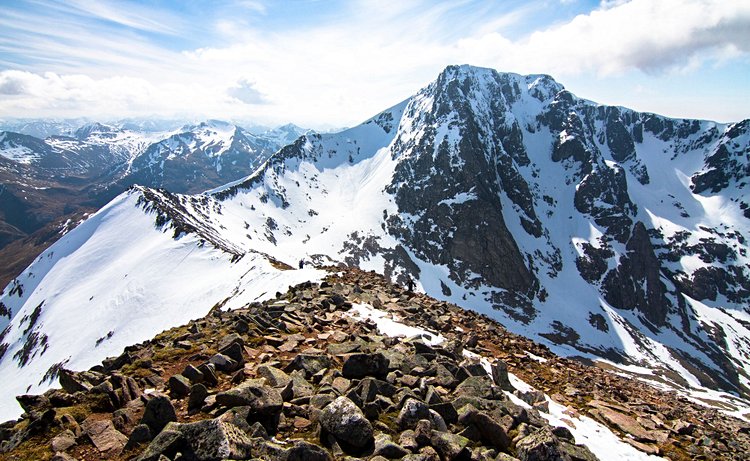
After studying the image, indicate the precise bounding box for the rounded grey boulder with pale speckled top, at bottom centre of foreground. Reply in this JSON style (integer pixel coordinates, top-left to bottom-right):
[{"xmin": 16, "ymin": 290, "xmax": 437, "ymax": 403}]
[{"xmin": 319, "ymin": 397, "xmax": 374, "ymax": 448}]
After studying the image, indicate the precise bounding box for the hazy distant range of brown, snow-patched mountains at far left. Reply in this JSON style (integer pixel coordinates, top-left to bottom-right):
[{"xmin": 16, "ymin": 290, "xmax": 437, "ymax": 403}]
[{"xmin": 0, "ymin": 120, "xmax": 306, "ymax": 285}]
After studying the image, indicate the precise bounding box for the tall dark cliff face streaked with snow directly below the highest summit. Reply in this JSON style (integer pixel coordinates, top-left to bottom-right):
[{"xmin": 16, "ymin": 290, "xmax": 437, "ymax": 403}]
[{"xmin": 387, "ymin": 68, "xmax": 539, "ymax": 298}]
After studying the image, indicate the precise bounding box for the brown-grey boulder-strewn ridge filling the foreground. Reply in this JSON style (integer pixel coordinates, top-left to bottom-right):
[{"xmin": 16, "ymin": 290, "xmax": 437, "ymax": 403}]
[{"xmin": 0, "ymin": 269, "xmax": 750, "ymax": 461}]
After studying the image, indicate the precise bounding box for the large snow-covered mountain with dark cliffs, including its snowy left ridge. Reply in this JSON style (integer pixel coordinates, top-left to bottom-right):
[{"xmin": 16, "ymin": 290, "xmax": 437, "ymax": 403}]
[{"xmin": 0, "ymin": 66, "xmax": 750, "ymax": 417}]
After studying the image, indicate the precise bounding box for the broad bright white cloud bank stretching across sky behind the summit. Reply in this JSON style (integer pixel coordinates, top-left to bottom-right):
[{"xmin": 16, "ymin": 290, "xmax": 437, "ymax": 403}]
[{"xmin": 0, "ymin": 0, "xmax": 750, "ymax": 126}]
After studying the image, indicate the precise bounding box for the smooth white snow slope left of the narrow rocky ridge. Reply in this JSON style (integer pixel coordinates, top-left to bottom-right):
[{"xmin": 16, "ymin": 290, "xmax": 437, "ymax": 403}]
[{"xmin": 0, "ymin": 190, "xmax": 322, "ymax": 420}]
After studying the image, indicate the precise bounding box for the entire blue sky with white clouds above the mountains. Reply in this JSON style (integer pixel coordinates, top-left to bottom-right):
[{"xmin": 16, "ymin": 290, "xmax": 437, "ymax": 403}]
[{"xmin": 0, "ymin": 0, "xmax": 750, "ymax": 129}]
